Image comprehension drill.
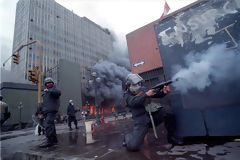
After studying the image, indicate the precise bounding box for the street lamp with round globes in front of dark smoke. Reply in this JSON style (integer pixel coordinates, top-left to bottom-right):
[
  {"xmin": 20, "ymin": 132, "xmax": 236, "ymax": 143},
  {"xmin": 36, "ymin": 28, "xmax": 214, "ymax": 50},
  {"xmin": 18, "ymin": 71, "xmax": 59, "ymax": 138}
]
[{"xmin": 88, "ymin": 72, "xmax": 101, "ymax": 124}]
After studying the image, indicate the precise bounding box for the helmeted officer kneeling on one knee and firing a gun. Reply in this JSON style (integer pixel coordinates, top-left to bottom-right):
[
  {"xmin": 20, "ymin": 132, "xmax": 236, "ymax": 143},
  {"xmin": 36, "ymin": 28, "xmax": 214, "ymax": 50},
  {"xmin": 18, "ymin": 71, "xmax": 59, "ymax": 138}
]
[{"xmin": 123, "ymin": 74, "xmax": 182, "ymax": 151}]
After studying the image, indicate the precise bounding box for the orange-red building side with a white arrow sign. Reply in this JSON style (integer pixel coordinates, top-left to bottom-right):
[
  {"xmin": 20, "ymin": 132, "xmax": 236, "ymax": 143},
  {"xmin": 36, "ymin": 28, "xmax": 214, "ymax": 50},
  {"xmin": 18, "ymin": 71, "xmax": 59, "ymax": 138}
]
[{"xmin": 126, "ymin": 20, "xmax": 164, "ymax": 86}]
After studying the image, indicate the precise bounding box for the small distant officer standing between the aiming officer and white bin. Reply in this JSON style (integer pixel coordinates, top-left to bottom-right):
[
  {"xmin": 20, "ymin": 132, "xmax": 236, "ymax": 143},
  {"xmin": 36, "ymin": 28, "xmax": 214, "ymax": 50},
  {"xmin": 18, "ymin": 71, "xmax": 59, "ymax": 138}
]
[{"xmin": 67, "ymin": 100, "xmax": 78, "ymax": 130}]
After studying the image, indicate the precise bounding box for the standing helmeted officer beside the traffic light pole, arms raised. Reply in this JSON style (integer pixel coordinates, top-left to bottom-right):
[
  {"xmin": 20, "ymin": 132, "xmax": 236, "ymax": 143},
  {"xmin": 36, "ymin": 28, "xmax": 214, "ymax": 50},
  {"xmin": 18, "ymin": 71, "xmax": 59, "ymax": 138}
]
[{"xmin": 39, "ymin": 77, "xmax": 61, "ymax": 148}]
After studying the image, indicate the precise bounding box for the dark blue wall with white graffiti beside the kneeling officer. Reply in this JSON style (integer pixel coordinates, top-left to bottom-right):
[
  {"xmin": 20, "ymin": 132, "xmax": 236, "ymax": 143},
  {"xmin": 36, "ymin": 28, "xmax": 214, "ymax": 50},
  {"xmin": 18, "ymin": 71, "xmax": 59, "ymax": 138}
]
[{"xmin": 155, "ymin": 0, "xmax": 240, "ymax": 136}]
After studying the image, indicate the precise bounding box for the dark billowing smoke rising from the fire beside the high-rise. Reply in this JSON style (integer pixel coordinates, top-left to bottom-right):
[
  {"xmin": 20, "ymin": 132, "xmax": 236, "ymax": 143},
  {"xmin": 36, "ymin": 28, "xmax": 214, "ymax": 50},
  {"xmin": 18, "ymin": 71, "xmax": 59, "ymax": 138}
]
[{"xmin": 87, "ymin": 31, "xmax": 130, "ymax": 104}]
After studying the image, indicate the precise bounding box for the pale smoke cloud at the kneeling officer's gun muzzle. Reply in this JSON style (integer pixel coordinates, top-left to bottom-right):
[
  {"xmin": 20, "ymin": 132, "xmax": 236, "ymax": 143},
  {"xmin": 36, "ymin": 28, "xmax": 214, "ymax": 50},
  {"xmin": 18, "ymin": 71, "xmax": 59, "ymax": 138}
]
[{"xmin": 173, "ymin": 45, "xmax": 240, "ymax": 94}]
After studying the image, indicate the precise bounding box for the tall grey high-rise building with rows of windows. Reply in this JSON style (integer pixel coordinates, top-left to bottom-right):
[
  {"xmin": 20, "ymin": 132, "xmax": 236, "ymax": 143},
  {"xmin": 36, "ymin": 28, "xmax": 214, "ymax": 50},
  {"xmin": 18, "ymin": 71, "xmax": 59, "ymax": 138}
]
[{"xmin": 11, "ymin": 0, "xmax": 113, "ymax": 82}]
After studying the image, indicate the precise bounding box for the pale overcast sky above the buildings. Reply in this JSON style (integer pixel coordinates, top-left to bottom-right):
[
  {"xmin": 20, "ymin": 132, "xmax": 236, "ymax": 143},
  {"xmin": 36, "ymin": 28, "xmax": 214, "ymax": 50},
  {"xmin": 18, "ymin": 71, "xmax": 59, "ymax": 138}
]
[{"xmin": 0, "ymin": 0, "xmax": 196, "ymax": 66}]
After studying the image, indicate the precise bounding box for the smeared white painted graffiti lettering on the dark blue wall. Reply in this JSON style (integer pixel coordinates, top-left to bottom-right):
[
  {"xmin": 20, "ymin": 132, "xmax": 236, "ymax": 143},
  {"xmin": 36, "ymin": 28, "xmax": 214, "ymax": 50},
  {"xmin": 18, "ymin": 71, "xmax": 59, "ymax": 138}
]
[{"xmin": 158, "ymin": 0, "xmax": 240, "ymax": 47}]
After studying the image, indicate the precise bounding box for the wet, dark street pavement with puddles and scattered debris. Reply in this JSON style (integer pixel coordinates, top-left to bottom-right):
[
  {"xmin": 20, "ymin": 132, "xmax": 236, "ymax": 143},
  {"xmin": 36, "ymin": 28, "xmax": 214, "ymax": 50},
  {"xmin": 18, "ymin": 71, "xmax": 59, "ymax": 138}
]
[{"xmin": 1, "ymin": 118, "xmax": 240, "ymax": 160}]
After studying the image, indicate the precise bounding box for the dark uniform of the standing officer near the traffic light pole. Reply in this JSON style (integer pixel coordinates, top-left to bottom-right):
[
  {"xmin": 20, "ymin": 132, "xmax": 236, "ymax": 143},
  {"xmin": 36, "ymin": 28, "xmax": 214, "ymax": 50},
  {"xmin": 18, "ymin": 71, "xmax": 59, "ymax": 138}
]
[{"xmin": 42, "ymin": 86, "xmax": 61, "ymax": 144}]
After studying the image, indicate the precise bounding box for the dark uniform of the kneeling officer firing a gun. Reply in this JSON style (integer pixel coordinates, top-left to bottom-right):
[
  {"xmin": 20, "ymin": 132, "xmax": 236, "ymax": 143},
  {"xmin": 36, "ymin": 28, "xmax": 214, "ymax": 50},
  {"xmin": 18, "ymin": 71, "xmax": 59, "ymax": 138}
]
[{"xmin": 124, "ymin": 87, "xmax": 175, "ymax": 151}]
